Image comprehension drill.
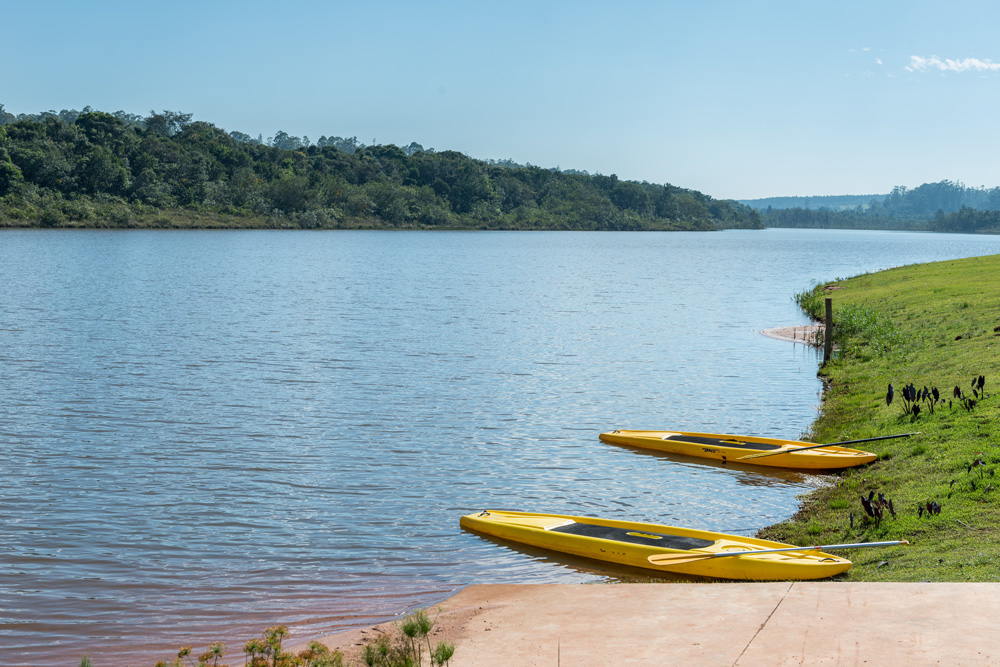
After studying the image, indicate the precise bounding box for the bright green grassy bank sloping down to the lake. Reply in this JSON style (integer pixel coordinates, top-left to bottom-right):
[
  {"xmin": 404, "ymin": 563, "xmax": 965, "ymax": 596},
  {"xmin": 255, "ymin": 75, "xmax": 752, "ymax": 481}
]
[{"xmin": 760, "ymin": 256, "xmax": 1000, "ymax": 581}]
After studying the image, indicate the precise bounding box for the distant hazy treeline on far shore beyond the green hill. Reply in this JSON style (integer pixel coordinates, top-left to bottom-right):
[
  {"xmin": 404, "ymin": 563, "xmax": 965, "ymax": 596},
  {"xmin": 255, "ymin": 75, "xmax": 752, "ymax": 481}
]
[{"xmin": 761, "ymin": 181, "xmax": 1000, "ymax": 233}]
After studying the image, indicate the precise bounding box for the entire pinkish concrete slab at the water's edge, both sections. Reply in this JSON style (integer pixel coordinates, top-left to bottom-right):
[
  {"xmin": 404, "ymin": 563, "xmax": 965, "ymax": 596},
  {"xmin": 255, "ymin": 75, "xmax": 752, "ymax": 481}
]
[{"xmin": 308, "ymin": 582, "xmax": 1000, "ymax": 667}]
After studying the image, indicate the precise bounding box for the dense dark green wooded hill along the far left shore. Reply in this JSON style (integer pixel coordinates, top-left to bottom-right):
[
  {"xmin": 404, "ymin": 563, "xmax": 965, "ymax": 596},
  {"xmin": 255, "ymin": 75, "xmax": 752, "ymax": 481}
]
[{"xmin": 0, "ymin": 105, "xmax": 762, "ymax": 230}]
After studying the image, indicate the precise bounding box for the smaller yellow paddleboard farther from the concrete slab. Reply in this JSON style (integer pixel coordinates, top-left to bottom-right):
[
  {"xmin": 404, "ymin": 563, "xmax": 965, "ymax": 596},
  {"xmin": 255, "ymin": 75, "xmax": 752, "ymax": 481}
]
[{"xmin": 600, "ymin": 431, "xmax": 878, "ymax": 470}]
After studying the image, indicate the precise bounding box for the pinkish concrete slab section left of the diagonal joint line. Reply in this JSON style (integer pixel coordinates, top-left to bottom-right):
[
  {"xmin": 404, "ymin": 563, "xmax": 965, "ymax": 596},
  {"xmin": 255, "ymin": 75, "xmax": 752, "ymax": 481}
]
[{"xmin": 444, "ymin": 583, "xmax": 789, "ymax": 667}]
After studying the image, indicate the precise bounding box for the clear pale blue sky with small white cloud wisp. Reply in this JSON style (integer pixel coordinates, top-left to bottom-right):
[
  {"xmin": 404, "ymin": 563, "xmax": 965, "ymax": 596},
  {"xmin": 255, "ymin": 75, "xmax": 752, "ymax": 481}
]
[{"xmin": 0, "ymin": 0, "xmax": 1000, "ymax": 198}]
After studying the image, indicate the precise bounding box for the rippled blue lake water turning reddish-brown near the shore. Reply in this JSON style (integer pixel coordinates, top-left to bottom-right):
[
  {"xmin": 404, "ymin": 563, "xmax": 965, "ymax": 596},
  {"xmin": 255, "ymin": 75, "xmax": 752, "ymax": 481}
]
[{"xmin": 0, "ymin": 230, "xmax": 1000, "ymax": 667}]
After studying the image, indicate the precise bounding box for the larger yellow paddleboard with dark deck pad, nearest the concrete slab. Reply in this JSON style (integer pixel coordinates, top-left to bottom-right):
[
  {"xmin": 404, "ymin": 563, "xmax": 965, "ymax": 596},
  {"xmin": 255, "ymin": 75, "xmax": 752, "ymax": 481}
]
[{"xmin": 461, "ymin": 510, "xmax": 851, "ymax": 581}]
